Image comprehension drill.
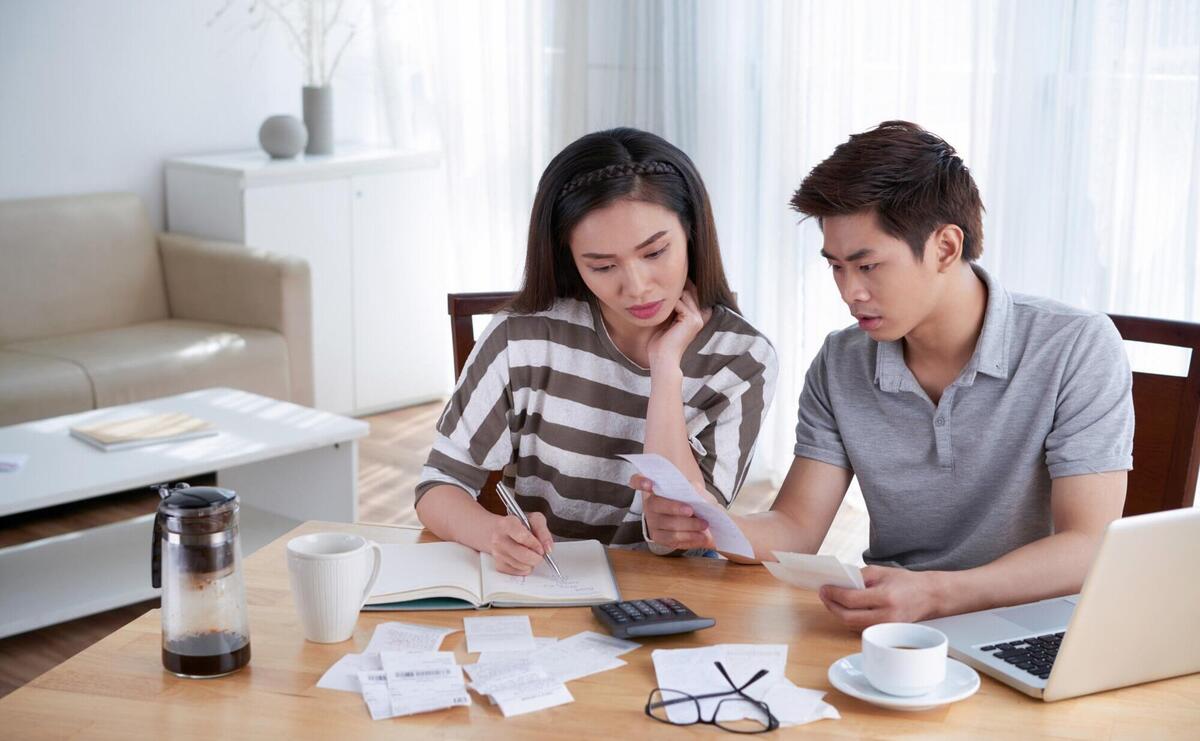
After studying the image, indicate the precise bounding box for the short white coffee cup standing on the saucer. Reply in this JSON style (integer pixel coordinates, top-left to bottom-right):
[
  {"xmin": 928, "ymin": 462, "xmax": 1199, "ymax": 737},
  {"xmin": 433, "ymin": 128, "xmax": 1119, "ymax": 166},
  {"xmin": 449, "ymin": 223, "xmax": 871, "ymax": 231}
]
[{"xmin": 863, "ymin": 622, "xmax": 949, "ymax": 697}]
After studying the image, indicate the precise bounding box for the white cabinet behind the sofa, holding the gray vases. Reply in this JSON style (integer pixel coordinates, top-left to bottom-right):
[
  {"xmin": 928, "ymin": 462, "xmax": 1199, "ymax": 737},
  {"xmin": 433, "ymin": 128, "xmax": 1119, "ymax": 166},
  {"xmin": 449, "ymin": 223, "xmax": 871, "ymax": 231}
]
[{"xmin": 167, "ymin": 141, "xmax": 452, "ymax": 414}]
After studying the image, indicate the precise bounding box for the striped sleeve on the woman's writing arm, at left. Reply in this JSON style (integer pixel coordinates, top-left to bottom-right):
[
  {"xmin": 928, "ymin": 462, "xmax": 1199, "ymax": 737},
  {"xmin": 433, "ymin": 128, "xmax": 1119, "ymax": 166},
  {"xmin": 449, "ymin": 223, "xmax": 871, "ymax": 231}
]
[{"xmin": 416, "ymin": 314, "xmax": 512, "ymax": 501}]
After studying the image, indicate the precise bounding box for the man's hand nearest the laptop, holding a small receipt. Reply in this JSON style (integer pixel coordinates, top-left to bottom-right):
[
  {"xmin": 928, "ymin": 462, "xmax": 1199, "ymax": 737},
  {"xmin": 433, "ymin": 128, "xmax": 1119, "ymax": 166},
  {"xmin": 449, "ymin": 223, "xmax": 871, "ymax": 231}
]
[{"xmin": 817, "ymin": 566, "xmax": 938, "ymax": 631}]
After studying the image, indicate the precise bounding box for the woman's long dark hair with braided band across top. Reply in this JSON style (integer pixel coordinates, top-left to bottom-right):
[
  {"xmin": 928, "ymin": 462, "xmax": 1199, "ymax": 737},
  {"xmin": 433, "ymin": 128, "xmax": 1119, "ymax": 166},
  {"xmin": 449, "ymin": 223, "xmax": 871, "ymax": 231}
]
[{"xmin": 509, "ymin": 128, "xmax": 737, "ymax": 314}]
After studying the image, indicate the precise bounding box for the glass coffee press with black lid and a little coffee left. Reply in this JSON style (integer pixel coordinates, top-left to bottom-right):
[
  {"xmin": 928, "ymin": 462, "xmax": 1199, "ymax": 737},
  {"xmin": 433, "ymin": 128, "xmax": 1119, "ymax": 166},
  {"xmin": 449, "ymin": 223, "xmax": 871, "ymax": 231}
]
[{"xmin": 150, "ymin": 483, "xmax": 250, "ymax": 677}]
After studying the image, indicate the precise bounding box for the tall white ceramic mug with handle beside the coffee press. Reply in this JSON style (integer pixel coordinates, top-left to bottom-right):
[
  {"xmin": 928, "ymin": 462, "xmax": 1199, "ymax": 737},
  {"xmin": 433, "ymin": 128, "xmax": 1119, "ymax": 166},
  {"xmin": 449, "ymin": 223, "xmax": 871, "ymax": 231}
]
[{"xmin": 288, "ymin": 532, "xmax": 383, "ymax": 643}]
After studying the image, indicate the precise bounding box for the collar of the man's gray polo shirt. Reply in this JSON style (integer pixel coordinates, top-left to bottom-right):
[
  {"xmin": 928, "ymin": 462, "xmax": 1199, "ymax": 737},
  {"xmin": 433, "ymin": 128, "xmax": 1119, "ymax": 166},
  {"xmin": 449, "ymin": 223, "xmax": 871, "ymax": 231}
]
[{"xmin": 875, "ymin": 263, "xmax": 1013, "ymax": 393}]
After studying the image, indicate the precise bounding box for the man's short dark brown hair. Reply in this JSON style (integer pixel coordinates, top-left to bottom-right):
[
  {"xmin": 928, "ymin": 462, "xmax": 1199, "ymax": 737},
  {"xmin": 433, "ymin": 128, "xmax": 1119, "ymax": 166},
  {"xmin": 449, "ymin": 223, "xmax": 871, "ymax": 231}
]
[{"xmin": 792, "ymin": 121, "xmax": 983, "ymax": 261}]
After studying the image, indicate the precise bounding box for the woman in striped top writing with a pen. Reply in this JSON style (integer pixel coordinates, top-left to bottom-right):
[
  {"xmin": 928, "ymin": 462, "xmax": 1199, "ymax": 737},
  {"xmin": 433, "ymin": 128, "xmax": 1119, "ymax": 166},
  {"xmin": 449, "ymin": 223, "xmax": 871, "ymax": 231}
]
[{"xmin": 416, "ymin": 128, "xmax": 776, "ymax": 574}]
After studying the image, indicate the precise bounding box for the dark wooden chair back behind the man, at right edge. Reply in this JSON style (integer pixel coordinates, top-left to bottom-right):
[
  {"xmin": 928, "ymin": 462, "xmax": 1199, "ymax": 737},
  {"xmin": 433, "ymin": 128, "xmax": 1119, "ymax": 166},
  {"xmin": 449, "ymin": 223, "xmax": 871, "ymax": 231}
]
[{"xmin": 1110, "ymin": 314, "xmax": 1200, "ymax": 516}]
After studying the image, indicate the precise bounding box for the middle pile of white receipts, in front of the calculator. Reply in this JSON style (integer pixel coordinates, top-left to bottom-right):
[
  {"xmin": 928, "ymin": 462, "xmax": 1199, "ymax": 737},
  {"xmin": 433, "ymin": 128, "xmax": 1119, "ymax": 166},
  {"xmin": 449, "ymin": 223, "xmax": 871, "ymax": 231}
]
[{"xmin": 463, "ymin": 616, "xmax": 638, "ymax": 717}]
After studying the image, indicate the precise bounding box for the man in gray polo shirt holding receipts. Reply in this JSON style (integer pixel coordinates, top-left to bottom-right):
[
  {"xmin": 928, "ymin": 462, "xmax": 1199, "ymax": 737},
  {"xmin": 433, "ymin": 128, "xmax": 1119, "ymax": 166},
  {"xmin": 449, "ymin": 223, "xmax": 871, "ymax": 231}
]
[{"xmin": 631, "ymin": 121, "xmax": 1134, "ymax": 628}]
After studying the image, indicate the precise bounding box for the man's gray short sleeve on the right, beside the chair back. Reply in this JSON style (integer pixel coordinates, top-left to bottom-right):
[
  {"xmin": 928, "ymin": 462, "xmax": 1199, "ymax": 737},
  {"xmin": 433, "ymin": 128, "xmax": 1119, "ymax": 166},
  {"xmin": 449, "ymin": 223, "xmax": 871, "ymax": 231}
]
[{"xmin": 1045, "ymin": 314, "xmax": 1134, "ymax": 478}]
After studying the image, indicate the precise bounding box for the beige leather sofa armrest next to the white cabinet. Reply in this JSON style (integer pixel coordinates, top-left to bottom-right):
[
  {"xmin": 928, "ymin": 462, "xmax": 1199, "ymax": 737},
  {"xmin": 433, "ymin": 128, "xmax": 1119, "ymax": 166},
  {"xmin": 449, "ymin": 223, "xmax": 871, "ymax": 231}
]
[{"xmin": 158, "ymin": 233, "xmax": 313, "ymax": 405}]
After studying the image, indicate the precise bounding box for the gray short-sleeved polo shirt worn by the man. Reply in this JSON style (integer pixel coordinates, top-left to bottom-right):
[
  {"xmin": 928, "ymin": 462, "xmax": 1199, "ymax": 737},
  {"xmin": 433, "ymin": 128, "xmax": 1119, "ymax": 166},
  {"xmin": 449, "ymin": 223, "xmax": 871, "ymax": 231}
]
[{"xmin": 796, "ymin": 265, "xmax": 1133, "ymax": 570}]
